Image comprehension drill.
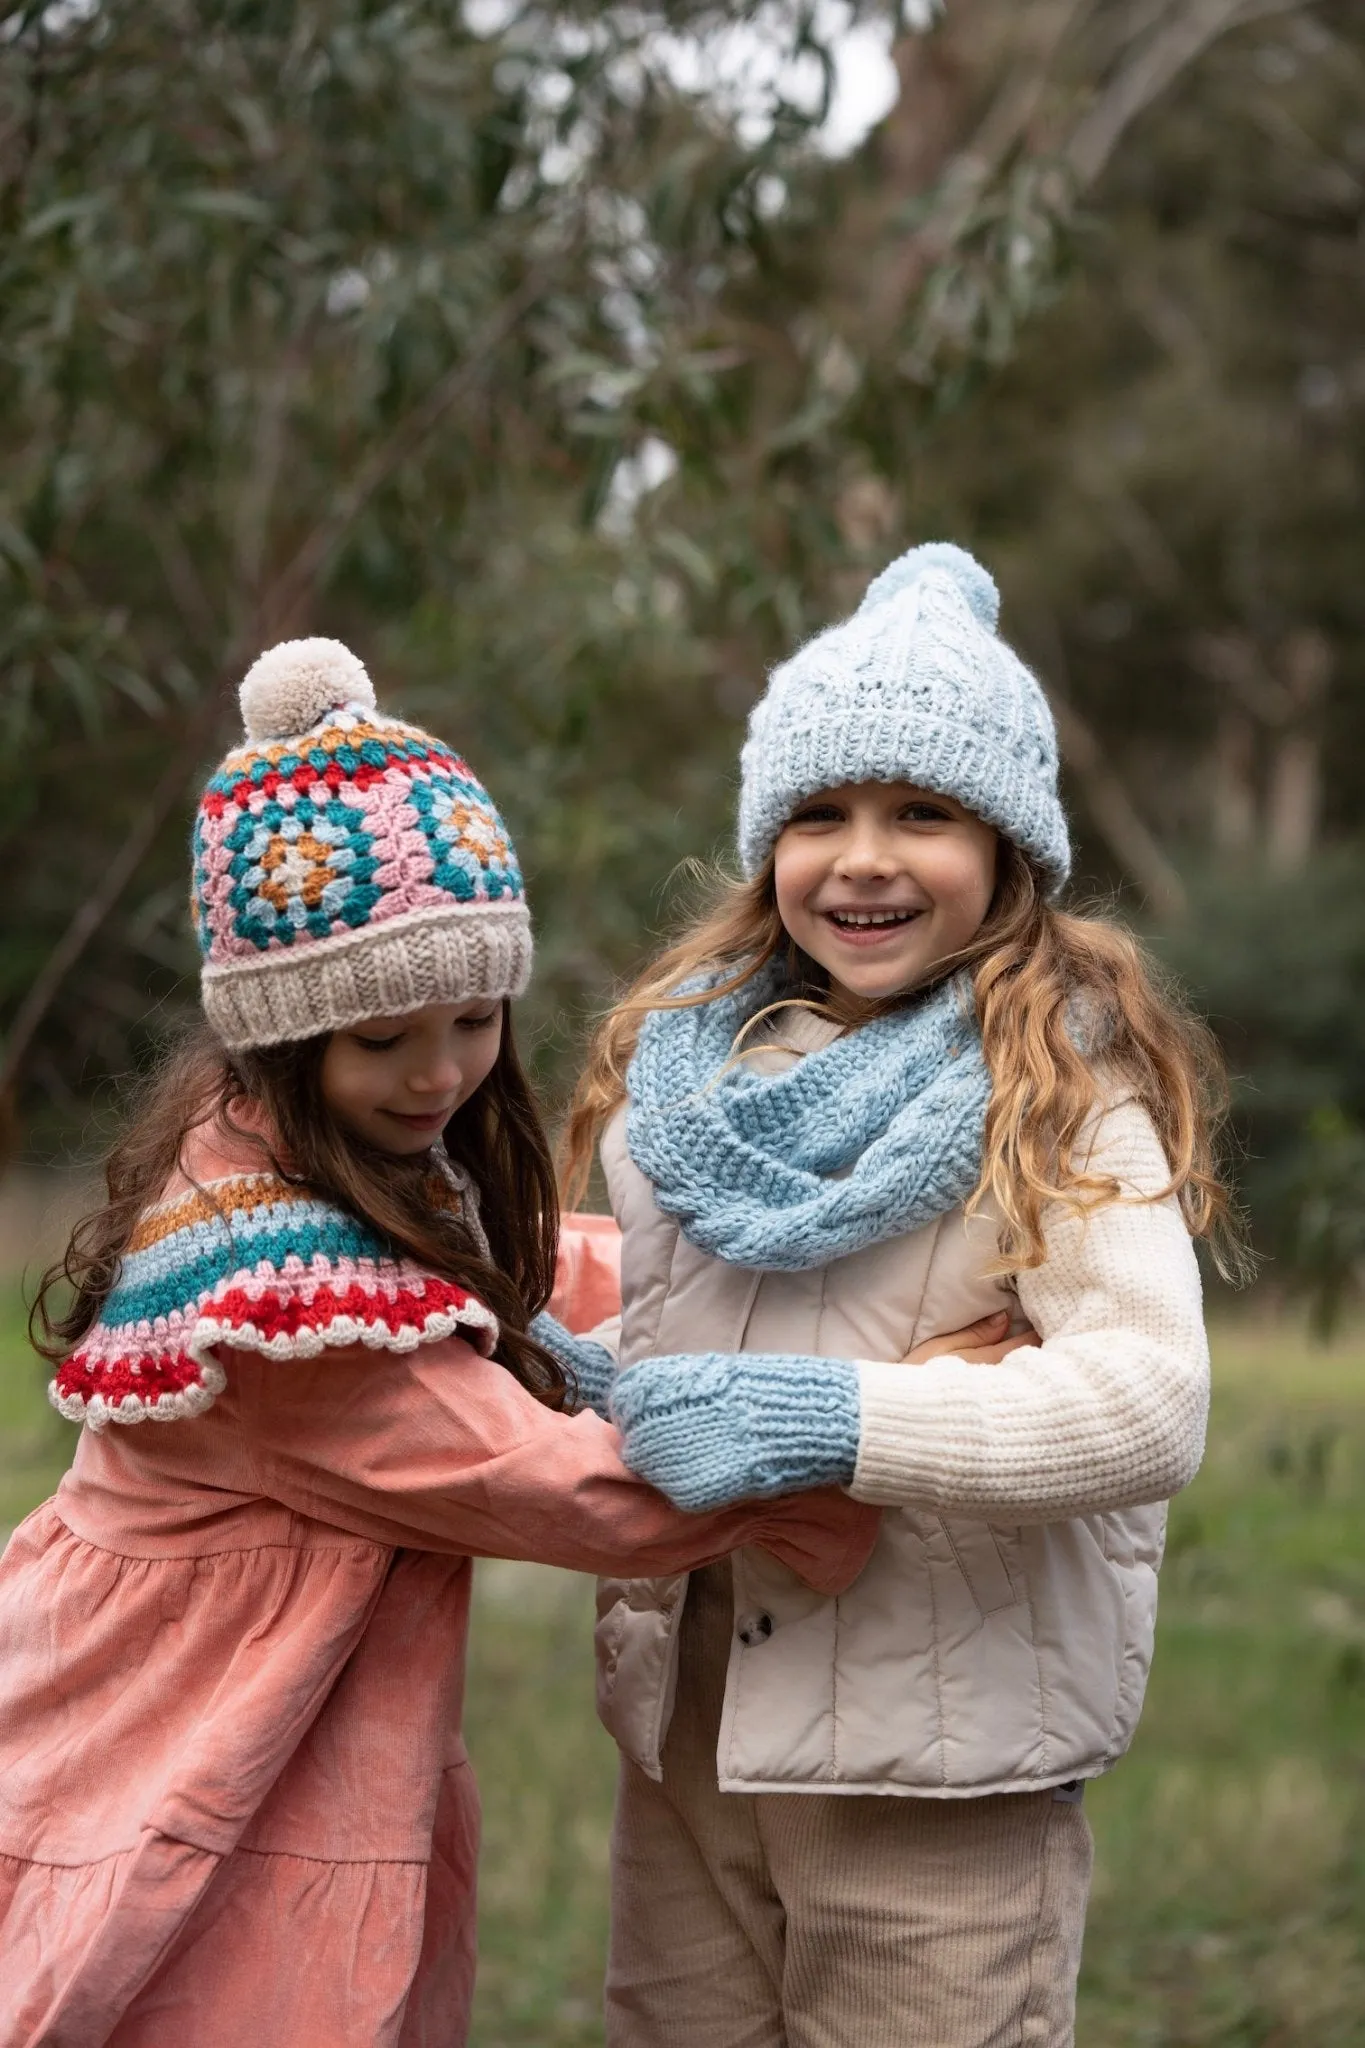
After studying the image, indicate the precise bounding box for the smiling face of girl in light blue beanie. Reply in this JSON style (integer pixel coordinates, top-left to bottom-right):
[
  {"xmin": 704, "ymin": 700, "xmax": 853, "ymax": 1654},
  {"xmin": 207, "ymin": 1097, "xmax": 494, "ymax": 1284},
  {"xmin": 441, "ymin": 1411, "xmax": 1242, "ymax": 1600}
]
[{"xmin": 774, "ymin": 782, "xmax": 997, "ymax": 1001}]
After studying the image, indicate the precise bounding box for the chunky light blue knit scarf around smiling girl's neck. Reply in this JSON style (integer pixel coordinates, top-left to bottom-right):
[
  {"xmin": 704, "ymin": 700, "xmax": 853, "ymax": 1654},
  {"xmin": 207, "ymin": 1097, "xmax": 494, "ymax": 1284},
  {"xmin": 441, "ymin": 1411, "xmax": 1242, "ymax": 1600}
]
[{"xmin": 626, "ymin": 969, "xmax": 990, "ymax": 1272}]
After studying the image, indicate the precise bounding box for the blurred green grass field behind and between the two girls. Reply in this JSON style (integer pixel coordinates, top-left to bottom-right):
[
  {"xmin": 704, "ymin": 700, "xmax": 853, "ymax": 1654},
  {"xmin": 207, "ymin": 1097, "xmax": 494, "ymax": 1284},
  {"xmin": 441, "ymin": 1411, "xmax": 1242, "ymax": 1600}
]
[{"xmin": 0, "ymin": 1290, "xmax": 1365, "ymax": 2048}]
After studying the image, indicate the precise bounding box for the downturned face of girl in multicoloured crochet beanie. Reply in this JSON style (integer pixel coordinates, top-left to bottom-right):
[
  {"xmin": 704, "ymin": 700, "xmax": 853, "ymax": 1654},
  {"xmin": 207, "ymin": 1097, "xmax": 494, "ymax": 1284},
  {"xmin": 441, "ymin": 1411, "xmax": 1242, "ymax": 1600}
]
[{"xmin": 321, "ymin": 997, "xmax": 503, "ymax": 1155}]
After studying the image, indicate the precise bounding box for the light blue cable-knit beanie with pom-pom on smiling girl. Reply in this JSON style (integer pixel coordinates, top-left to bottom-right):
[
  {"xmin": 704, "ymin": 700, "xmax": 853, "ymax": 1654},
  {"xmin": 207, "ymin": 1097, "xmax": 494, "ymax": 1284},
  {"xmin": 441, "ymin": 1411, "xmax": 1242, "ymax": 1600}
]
[{"xmin": 739, "ymin": 541, "xmax": 1070, "ymax": 891}]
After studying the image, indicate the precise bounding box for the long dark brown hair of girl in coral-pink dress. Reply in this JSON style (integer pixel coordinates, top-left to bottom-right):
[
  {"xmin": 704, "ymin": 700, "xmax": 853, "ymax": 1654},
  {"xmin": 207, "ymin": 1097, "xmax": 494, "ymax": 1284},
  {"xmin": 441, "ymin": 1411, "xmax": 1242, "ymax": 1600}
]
[{"xmin": 29, "ymin": 1004, "xmax": 571, "ymax": 1409}]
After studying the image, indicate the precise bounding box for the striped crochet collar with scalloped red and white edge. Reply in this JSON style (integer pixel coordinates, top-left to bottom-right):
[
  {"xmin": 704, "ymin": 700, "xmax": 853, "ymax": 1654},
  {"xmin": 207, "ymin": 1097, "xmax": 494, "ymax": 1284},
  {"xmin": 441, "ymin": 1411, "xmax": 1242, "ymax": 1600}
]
[{"xmin": 56, "ymin": 1174, "xmax": 497, "ymax": 1430}]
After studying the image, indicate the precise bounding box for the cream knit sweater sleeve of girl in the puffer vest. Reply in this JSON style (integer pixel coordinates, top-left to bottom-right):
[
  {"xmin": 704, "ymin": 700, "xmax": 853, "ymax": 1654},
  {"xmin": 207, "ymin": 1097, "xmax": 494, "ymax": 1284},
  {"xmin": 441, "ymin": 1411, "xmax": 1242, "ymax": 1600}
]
[{"xmin": 849, "ymin": 1102, "xmax": 1209, "ymax": 1522}]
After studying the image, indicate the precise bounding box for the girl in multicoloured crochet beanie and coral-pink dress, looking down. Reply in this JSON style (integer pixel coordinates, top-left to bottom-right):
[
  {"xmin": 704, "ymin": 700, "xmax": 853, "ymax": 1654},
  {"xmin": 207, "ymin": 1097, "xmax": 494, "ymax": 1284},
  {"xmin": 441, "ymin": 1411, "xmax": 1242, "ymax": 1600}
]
[{"xmin": 0, "ymin": 641, "xmax": 878, "ymax": 2048}]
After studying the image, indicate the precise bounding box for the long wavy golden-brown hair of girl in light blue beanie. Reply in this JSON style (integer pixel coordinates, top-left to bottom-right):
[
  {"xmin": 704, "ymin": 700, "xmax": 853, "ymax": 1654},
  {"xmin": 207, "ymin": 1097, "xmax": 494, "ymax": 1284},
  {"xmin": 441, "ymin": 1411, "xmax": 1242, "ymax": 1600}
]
[{"xmin": 561, "ymin": 840, "xmax": 1250, "ymax": 1280}]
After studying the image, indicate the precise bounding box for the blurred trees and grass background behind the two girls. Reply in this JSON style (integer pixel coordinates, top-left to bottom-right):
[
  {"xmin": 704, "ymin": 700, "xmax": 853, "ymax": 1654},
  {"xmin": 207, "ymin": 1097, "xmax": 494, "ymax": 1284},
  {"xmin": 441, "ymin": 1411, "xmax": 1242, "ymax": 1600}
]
[{"xmin": 0, "ymin": 0, "xmax": 1365, "ymax": 2048}]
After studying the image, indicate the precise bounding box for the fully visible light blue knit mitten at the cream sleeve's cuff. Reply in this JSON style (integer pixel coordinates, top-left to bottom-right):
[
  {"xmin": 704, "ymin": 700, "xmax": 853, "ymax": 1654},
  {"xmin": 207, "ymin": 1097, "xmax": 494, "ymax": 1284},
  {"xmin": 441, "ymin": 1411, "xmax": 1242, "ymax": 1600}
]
[{"xmin": 612, "ymin": 1352, "xmax": 860, "ymax": 1513}]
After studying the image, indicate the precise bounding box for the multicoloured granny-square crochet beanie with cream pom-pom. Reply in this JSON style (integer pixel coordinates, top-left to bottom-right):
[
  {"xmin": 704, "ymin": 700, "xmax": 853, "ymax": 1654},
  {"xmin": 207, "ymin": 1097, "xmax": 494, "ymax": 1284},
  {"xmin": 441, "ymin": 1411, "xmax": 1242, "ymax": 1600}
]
[{"xmin": 192, "ymin": 639, "xmax": 532, "ymax": 1049}]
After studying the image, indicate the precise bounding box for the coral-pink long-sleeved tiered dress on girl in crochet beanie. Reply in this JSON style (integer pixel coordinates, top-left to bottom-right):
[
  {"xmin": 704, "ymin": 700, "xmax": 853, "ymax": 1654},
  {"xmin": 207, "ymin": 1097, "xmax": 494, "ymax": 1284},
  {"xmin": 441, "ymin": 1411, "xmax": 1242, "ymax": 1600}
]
[{"xmin": 0, "ymin": 1135, "xmax": 876, "ymax": 2048}]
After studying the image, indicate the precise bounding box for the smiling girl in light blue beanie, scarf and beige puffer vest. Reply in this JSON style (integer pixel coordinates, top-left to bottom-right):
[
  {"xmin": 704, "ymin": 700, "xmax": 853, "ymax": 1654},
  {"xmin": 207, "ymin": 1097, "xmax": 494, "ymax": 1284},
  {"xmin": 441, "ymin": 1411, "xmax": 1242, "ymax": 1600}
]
[{"xmin": 552, "ymin": 545, "xmax": 1236, "ymax": 2048}]
